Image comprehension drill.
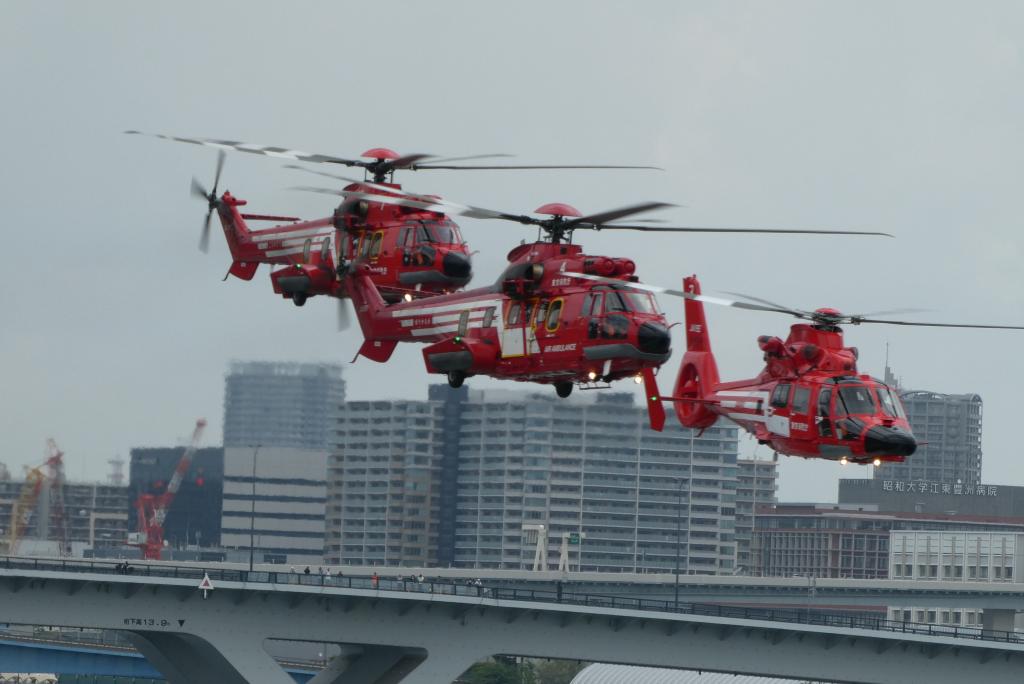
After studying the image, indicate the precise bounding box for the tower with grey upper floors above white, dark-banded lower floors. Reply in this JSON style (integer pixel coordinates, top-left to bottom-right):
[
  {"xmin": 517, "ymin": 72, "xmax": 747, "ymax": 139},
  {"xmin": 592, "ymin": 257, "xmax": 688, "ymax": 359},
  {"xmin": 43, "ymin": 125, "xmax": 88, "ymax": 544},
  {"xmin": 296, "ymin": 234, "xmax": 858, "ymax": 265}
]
[{"xmin": 221, "ymin": 361, "xmax": 345, "ymax": 563}]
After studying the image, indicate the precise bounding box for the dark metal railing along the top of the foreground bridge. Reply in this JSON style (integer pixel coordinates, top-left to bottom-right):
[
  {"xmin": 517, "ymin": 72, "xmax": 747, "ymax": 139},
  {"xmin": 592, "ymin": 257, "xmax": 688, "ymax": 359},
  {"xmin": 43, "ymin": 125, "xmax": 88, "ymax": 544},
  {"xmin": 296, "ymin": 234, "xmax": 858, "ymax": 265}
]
[{"xmin": 0, "ymin": 556, "xmax": 1024, "ymax": 643}]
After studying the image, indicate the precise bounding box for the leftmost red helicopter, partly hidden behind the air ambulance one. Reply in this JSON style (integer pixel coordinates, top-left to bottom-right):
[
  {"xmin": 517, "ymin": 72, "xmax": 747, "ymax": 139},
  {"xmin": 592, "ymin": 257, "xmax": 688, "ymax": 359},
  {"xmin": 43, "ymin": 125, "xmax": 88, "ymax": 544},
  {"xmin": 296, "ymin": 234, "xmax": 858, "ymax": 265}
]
[{"xmin": 126, "ymin": 131, "xmax": 655, "ymax": 312}]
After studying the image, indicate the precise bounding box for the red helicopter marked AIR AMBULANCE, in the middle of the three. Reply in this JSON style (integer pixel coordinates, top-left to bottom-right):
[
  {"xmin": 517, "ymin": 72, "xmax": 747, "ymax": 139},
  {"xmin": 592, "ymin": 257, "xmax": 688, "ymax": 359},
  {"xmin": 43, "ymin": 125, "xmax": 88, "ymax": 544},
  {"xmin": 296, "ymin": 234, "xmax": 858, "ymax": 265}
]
[{"xmin": 317, "ymin": 181, "xmax": 880, "ymax": 397}]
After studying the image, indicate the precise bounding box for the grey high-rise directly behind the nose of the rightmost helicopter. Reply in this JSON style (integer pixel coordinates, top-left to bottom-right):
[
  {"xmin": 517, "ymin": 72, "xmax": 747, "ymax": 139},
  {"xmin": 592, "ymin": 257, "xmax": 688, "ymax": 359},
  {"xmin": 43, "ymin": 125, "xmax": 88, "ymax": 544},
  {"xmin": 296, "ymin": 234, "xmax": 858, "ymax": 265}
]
[{"xmin": 874, "ymin": 391, "xmax": 982, "ymax": 486}]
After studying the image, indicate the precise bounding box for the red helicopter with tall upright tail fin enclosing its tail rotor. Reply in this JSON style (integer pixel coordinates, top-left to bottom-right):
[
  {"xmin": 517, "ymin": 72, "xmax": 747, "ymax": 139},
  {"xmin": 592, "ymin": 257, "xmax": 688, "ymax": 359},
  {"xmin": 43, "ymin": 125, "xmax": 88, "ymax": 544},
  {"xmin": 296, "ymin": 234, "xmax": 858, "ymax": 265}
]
[{"xmin": 571, "ymin": 272, "xmax": 1024, "ymax": 466}]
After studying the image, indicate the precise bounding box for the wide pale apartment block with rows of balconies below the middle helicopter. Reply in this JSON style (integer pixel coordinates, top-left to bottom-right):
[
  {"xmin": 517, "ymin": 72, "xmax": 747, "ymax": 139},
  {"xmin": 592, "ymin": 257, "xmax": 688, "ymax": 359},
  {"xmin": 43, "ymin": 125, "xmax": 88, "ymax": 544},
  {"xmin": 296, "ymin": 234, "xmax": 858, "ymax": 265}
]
[{"xmin": 328, "ymin": 388, "xmax": 737, "ymax": 573}]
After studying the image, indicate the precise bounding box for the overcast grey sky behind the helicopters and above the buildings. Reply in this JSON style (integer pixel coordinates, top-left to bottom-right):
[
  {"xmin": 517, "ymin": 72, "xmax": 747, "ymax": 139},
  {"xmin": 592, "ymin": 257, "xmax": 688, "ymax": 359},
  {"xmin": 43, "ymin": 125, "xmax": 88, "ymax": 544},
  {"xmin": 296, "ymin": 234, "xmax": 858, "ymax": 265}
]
[{"xmin": 0, "ymin": 1, "xmax": 1024, "ymax": 500}]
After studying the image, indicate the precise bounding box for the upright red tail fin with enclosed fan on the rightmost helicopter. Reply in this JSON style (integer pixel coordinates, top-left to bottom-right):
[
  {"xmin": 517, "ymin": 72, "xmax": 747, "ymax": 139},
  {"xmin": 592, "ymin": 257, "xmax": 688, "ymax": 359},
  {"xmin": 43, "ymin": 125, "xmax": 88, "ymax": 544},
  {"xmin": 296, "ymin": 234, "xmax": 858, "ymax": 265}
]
[{"xmin": 673, "ymin": 275, "xmax": 719, "ymax": 429}]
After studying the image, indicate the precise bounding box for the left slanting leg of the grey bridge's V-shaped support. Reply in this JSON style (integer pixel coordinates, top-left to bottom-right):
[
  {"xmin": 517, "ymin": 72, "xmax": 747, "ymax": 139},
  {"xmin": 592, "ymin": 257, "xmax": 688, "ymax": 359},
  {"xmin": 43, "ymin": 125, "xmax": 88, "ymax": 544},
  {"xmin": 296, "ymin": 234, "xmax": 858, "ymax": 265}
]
[{"xmin": 127, "ymin": 632, "xmax": 295, "ymax": 684}]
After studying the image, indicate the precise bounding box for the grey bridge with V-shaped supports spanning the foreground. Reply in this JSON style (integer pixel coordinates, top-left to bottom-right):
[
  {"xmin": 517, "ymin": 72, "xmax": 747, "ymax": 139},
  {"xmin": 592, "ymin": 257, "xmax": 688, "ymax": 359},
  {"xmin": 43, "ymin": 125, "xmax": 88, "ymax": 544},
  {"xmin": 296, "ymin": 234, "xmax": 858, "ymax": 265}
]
[{"xmin": 0, "ymin": 559, "xmax": 1024, "ymax": 684}]
